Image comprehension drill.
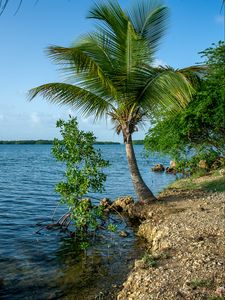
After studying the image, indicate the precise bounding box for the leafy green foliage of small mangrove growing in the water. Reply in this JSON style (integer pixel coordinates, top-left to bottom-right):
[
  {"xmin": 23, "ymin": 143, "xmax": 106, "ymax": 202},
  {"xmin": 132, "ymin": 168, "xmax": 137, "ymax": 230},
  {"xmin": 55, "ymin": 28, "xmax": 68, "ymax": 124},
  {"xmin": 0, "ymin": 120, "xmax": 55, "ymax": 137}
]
[{"xmin": 52, "ymin": 117, "xmax": 108, "ymax": 231}]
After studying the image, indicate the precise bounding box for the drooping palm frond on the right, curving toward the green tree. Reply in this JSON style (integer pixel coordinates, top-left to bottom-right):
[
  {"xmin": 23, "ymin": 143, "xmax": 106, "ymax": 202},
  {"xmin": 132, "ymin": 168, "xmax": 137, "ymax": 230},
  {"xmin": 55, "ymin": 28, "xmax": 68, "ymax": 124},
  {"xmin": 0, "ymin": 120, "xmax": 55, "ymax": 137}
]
[{"xmin": 133, "ymin": 66, "xmax": 194, "ymax": 114}]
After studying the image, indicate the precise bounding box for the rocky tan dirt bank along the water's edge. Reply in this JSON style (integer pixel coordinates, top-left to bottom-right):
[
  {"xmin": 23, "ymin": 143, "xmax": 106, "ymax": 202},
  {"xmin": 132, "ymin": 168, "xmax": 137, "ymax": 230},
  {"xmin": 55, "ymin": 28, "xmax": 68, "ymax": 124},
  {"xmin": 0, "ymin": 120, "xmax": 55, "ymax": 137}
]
[{"xmin": 117, "ymin": 172, "xmax": 225, "ymax": 300}]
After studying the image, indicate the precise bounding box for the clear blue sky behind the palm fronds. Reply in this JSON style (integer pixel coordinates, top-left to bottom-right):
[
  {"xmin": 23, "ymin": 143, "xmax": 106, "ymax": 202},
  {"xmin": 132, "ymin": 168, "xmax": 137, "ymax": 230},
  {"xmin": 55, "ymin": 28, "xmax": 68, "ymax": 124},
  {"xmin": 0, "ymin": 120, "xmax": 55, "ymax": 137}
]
[{"xmin": 0, "ymin": 0, "xmax": 224, "ymax": 141}]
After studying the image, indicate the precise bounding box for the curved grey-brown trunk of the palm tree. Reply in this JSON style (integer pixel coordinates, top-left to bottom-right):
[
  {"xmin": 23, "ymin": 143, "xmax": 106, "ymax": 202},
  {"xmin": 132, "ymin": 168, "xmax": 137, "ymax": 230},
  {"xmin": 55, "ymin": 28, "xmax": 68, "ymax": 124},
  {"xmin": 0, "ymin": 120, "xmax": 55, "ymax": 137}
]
[{"xmin": 125, "ymin": 135, "xmax": 156, "ymax": 203}]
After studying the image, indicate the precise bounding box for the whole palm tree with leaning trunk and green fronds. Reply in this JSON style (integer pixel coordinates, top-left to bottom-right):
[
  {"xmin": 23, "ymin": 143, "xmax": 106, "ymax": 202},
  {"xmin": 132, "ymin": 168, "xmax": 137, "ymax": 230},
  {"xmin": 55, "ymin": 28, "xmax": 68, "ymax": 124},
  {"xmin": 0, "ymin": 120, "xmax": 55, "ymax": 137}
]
[{"xmin": 30, "ymin": 0, "xmax": 195, "ymax": 202}]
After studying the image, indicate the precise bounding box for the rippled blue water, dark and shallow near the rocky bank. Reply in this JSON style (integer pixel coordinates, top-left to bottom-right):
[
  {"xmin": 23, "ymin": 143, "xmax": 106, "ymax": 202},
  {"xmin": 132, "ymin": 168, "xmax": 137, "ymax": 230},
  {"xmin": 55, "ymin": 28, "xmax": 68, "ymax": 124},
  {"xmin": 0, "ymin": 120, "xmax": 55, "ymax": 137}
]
[{"xmin": 0, "ymin": 145, "xmax": 175, "ymax": 300}]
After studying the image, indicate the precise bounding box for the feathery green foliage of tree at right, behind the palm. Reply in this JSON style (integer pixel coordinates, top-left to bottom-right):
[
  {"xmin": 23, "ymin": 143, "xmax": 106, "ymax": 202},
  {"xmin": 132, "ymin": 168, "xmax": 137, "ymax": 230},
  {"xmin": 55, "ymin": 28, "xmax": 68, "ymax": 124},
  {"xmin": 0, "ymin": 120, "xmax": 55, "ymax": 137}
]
[{"xmin": 145, "ymin": 41, "xmax": 225, "ymax": 169}]
